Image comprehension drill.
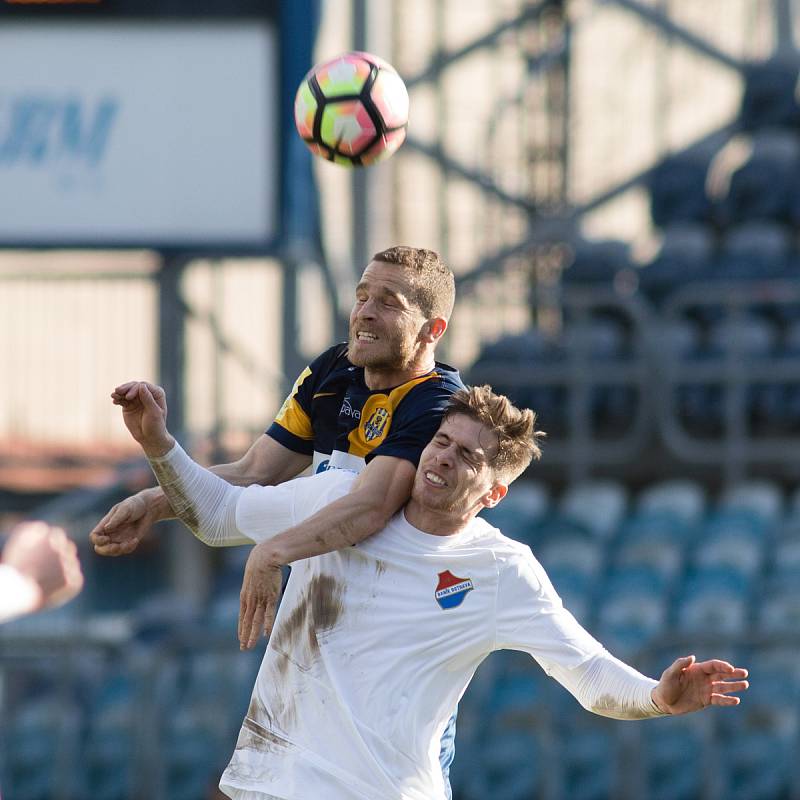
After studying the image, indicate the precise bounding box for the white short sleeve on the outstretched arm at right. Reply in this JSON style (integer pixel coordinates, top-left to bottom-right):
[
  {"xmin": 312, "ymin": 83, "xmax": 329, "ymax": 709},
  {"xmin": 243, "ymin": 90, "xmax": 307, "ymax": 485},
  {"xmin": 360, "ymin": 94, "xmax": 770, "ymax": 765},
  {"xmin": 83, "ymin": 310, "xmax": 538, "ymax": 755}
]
[{"xmin": 496, "ymin": 545, "xmax": 603, "ymax": 674}]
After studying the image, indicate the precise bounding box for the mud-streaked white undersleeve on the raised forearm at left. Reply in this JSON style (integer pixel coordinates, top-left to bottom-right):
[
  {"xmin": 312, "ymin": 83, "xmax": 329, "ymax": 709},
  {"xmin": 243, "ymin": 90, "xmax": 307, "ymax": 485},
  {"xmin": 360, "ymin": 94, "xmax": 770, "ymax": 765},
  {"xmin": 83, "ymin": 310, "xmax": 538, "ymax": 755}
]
[{"xmin": 148, "ymin": 443, "xmax": 252, "ymax": 547}]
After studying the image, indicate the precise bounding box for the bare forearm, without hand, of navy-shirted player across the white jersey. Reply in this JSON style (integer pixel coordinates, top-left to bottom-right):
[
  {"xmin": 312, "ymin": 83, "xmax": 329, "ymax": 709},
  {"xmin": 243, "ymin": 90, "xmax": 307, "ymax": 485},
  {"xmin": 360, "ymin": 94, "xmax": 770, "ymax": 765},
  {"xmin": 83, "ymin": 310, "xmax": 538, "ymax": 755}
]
[{"xmin": 262, "ymin": 491, "xmax": 391, "ymax": 566}]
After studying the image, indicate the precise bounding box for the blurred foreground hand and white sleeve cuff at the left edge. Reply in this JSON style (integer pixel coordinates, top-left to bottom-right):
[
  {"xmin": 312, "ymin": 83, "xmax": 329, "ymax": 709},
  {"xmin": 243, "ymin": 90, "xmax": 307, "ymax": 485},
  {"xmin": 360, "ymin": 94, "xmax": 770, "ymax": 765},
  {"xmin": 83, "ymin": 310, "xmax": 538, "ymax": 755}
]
[{"xmin": 0, "ymin": 521, "xmax": 83, "ymax": 622}]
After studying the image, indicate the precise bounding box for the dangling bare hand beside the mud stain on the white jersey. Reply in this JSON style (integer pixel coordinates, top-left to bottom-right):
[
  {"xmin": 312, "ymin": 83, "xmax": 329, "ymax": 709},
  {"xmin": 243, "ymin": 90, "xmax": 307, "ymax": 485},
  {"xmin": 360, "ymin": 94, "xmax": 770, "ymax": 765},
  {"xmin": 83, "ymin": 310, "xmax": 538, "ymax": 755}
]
[{"xmin": 239, "ymin": 542, "xmax": 283, "ymax": 650}]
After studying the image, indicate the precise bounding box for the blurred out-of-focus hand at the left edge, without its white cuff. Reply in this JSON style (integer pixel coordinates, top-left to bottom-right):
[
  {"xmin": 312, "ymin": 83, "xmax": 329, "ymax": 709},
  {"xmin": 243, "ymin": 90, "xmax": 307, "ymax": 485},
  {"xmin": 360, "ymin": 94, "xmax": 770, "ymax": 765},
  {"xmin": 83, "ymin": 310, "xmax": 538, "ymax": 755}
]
[{"xmin": 2, "ymin": 521, "xmax": 83, "ymax": 610}]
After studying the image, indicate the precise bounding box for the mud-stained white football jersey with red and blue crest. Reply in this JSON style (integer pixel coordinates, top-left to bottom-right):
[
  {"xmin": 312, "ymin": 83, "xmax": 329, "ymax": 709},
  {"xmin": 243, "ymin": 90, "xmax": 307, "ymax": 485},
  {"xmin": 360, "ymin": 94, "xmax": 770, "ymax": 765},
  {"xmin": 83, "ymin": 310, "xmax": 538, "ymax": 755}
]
[{"xmin": 220, "ymin": 470, "xmax": 602, "ymax": 800}]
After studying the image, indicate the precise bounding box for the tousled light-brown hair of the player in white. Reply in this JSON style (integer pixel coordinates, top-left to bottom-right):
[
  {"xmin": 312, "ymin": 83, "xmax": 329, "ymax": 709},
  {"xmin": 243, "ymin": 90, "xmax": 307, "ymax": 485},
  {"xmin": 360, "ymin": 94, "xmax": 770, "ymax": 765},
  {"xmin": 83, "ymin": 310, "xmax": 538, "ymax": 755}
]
[{"xmin": 444, "ymin": 385, "xmax": 547, "ymax": 484}]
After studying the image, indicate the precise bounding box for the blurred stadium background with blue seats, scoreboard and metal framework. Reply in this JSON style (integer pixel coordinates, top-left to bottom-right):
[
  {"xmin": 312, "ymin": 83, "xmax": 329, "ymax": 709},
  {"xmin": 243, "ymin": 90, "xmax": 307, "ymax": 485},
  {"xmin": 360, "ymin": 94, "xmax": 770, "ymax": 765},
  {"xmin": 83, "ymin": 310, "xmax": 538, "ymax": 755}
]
[{"xmin": 0, "ymin": 0, "xmax": 800, "ymax": 800}]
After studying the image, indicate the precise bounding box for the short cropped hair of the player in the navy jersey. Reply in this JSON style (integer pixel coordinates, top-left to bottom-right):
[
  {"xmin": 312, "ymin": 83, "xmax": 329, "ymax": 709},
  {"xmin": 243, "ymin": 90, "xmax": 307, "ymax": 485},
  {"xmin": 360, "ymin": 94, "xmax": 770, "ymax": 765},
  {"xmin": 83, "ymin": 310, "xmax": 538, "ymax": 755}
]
[{"xmin": 372, "ymin": 246, "xmax": 456, "ymax": 321}]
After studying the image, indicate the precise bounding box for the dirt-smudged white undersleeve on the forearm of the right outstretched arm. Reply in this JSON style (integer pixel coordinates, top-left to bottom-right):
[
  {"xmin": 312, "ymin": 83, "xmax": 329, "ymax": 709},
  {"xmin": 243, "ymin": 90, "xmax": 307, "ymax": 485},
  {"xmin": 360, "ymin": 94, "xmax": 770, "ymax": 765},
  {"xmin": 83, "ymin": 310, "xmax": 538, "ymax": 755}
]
[{"xmin": 553, "ymin": 650, "xmax": 664, "ymax": 719}]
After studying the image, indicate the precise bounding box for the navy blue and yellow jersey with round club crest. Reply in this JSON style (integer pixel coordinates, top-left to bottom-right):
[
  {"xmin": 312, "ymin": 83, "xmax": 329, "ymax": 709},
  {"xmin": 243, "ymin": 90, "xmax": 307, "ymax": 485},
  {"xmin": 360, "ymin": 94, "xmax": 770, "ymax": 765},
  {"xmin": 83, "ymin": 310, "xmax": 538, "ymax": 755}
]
[{"xmin": 267, "ymin": 344, "xmax": 464, "ymax": 472}]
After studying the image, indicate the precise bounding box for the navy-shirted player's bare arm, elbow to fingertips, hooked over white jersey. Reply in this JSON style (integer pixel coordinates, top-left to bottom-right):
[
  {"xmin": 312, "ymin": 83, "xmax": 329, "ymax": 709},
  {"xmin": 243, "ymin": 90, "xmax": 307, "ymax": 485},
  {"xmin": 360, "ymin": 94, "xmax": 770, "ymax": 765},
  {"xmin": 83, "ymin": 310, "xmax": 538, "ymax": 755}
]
[{"xmin": 239, "ymin": 456, "xmax": 416, "ymax": 649}]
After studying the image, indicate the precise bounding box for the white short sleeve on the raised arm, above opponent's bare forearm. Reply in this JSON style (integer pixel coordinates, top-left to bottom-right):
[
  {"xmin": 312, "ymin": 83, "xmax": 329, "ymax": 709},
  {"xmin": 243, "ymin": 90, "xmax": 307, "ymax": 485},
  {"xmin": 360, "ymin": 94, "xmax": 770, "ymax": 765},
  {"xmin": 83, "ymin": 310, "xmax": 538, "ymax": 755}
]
[{"xmin": 236, "ymin": 469, "xmax": 355, "ymax": 543}]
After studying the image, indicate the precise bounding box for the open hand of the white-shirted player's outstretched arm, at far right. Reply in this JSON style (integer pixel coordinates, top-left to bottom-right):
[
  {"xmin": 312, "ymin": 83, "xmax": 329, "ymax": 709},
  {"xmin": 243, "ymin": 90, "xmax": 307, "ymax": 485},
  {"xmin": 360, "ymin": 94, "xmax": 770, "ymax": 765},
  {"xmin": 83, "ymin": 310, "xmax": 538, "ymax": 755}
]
[{"xmin": 652, "ymin": 656, "xmax": 749, "ymax": 714}]
